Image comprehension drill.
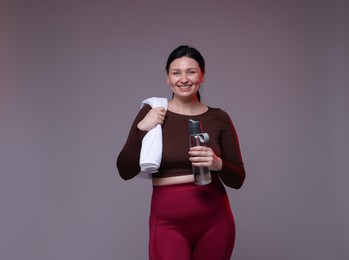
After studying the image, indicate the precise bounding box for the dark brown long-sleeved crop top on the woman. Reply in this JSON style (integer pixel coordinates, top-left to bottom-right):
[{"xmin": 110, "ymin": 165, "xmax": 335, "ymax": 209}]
[{"xmin": 117, "ymin": 105, "xmax": 245, "ymax": 188}]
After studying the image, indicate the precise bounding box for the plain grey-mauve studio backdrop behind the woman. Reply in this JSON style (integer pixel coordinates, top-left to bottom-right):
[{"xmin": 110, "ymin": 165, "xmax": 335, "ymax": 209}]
[{"xmin": 0, "ymin": 0, "xmax": 349, "ymax": 260}]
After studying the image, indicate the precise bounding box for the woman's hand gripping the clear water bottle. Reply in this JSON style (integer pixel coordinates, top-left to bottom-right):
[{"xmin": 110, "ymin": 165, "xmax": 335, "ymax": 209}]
[{"xmin": 189, "ymin": 146, "xmax": 222, "ymax": 171}]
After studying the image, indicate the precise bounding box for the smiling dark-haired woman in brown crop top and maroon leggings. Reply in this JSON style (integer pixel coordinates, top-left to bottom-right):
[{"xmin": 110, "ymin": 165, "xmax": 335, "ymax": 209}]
[{"xmin": 117, "ymin": 46, "xmax": 245, "ymax": 260}]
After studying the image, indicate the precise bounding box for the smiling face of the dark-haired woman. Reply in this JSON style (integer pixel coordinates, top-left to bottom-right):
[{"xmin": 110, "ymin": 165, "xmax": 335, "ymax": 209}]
[{"xmin": 167, "ymin": 56, "xmax": 204, "ymax": 98}]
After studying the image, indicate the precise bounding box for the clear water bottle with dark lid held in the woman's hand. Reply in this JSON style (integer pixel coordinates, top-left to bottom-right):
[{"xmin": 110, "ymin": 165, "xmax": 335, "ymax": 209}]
[{"xmin": 189, "ymin": 119, "xmax": 211, "ymax": 185}]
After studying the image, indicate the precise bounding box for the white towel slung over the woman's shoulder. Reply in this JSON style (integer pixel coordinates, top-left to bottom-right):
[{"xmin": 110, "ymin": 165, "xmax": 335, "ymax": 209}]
[{"xmin": 138, "ymin": 97, "xmax": 168, "ymax": 179}]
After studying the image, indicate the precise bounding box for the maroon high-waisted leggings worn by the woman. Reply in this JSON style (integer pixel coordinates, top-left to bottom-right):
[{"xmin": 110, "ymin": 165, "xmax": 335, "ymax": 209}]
[{"xmin": 149, "ymin": 178, "xmax": 235, "ymax": 260}]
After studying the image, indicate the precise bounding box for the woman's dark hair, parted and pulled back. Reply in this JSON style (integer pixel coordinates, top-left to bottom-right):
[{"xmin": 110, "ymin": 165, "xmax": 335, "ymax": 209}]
[{"xmin": 165, "ymin": 45, "xmax": 205, "ymax": 101}]
